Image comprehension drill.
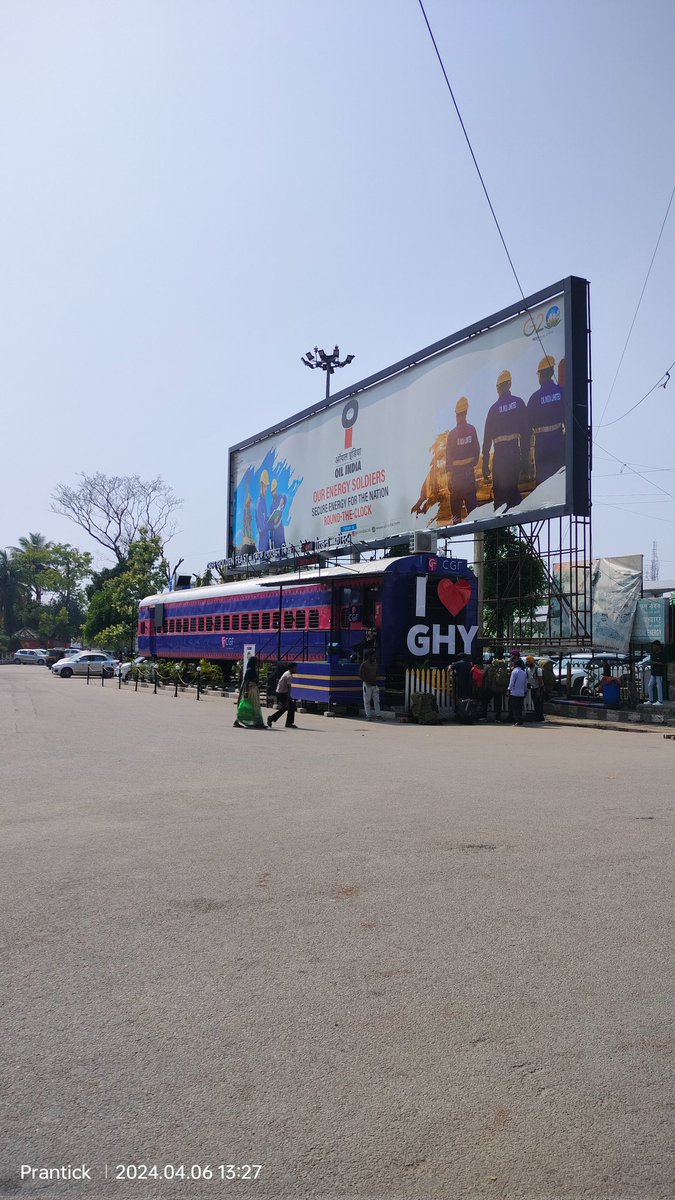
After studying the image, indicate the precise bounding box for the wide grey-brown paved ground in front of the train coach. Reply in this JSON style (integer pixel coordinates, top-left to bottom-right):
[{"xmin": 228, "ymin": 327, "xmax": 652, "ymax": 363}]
[{"xmin": 0, "ymin": 666, "xmax": 675, "ymax": 1200}]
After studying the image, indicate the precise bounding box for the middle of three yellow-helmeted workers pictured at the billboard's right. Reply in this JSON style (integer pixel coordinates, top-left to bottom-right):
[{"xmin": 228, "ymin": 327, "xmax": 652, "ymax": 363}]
[{"xmin": 483, "ymin": 371, "xmax": 530, "ymax": 510}]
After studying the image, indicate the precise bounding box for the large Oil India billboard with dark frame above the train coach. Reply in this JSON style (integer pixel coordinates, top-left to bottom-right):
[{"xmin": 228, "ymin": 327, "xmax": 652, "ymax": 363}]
[{"xmin": 228, "ymin": 277, "xmax": 590, "ymax": 557}]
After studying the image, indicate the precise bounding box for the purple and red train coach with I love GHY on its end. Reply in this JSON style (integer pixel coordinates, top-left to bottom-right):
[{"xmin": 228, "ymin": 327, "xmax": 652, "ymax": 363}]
[{"xmin": 138, "ymin": 554, "xmax": 478, "ymax": 706}]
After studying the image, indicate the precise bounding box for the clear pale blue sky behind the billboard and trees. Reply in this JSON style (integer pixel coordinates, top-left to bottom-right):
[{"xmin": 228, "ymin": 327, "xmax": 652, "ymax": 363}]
[{"xmin": 0, "ymin": 0, "xmax": 675, "ymax": 577}]
